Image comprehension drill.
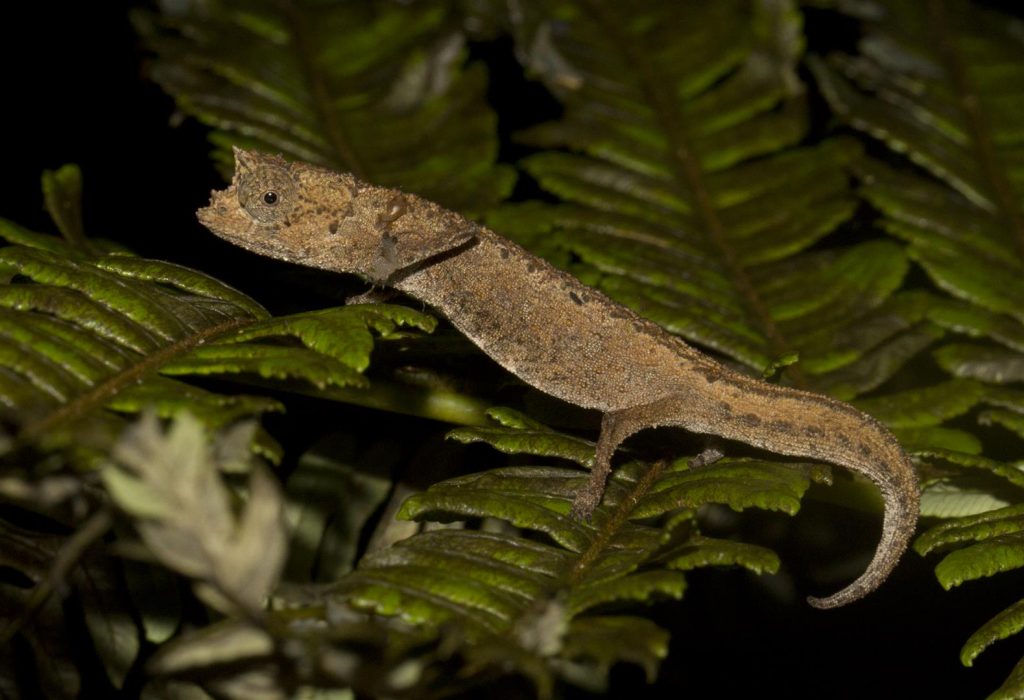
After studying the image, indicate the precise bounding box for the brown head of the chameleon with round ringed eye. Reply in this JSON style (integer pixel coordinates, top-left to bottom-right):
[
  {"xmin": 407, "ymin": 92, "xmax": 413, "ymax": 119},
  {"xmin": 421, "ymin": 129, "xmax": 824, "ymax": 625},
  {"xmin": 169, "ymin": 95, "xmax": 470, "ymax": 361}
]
[{"xmin": 197, "ymin": 147, "xmax": 377, "ymax": 272}]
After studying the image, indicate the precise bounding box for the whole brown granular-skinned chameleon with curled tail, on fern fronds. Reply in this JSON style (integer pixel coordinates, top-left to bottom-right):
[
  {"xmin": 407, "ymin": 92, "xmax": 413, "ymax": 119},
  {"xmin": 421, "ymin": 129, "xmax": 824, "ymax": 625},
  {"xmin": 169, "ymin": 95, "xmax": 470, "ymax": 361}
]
[{"xmin": 198, "ymin": 148, "xmax": 920, "ymax": 608}]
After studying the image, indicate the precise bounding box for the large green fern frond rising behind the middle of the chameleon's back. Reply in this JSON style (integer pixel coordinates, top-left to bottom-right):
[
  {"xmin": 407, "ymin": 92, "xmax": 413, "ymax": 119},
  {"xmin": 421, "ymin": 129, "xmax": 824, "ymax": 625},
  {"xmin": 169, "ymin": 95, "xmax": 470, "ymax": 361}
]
[{"xmin": 489, "ymin": 2, "xmax": 939, "ymax": 398}]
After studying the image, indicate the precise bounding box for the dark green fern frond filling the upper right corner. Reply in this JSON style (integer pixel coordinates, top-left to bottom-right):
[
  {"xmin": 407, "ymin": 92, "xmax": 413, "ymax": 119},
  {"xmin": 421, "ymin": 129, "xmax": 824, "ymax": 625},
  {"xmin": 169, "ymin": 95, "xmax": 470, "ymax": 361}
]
[{"xmin": 811, "ymin": 0, "xmax": 1024, "ymax": 351}]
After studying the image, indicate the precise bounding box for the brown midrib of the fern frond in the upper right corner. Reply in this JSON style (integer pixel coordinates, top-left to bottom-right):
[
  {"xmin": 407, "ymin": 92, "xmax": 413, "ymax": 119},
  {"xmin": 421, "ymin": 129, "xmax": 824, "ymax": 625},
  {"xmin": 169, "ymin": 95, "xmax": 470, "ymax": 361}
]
[{"xmin": 928, "ymin": 0, "xmax": 1024, "ymax": 261}]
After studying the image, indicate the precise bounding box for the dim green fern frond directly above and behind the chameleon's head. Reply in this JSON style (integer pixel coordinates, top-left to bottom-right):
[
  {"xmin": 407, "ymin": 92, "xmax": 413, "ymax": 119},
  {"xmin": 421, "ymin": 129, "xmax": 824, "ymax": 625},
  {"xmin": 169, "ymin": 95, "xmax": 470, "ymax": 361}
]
[{"xmin": 135, "ymin": 0, "xmax": 514, "ymax": 212}]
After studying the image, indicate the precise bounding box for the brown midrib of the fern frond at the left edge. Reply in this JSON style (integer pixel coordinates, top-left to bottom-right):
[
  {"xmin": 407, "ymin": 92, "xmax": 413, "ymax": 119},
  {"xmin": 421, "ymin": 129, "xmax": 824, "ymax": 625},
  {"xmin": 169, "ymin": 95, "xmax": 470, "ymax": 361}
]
[{"xmin": 16, "ymin": 318, "xmax": 253, "ymax": 446}]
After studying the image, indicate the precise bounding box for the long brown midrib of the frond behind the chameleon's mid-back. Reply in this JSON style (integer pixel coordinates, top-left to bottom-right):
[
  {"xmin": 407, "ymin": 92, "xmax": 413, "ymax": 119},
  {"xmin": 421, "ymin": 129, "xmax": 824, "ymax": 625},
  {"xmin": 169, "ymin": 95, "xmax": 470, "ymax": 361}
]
[{"xmin": 588, "ymin": 0, "xmax": 807, "ymax": 387}]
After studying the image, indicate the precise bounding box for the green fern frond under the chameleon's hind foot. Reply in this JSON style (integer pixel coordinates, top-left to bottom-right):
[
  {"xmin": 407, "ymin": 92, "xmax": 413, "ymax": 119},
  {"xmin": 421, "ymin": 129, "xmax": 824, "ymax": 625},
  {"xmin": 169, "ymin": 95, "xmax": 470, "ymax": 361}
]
[{"xmin": 327, "ymin": 408, "xmax": 827, "ymax": 689}]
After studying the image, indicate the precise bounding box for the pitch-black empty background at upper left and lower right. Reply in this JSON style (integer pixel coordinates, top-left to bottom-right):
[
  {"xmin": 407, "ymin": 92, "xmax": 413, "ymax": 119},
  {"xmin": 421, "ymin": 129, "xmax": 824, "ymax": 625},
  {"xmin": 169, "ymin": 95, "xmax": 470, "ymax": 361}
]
[{"xmin": 6, "ymin": 0, "xmax": 1024, "ymax": 698}]
